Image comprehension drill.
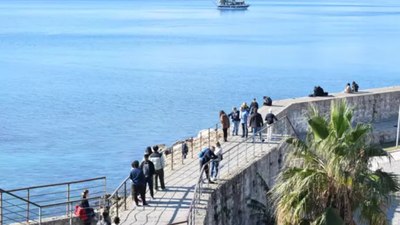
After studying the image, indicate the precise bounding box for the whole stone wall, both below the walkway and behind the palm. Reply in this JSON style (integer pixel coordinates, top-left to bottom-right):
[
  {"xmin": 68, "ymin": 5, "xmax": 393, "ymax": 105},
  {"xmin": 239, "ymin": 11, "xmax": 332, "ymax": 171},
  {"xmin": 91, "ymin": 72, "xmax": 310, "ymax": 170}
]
[{"xmin": 204, "ymin": 89, "xmax": 400, "ymax": 225}]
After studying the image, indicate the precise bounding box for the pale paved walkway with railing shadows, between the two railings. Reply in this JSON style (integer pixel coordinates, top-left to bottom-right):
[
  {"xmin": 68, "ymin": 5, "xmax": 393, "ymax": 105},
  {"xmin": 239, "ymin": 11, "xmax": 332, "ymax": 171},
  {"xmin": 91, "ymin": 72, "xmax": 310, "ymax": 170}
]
[{"xmin": 120, "ymin": 136, "xmax": 278, "ymax": 225}]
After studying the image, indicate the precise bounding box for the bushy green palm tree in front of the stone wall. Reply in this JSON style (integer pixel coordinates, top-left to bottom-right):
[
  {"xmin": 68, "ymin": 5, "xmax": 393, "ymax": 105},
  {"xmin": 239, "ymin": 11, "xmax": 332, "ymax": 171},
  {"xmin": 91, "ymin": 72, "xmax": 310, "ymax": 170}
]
[{"xmin": 271, "ymin": 100, "xmax": 400, "ymax": 225}]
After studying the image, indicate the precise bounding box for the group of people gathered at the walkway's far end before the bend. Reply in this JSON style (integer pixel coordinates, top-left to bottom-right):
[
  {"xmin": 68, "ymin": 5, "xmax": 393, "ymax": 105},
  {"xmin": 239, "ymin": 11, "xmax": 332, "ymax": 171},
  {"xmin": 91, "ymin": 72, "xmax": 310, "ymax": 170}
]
[{"xmin": 219, "ymin": 96, "xmax": 278, "ymax": 142}]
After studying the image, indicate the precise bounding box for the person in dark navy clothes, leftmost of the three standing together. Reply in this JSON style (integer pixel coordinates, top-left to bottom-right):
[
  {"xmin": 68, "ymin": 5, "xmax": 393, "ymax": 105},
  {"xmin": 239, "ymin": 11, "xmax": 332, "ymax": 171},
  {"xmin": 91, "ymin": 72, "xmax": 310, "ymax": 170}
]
[{"xmin": 129, "ymin": 160, "xmax": 148, "ymax": 206}]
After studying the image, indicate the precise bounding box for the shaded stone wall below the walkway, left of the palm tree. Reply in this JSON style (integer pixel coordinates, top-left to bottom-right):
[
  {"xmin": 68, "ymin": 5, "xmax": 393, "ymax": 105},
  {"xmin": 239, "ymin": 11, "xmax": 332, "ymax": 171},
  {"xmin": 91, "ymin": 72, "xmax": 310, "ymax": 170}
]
[{"xmin": 204, "ymin": 144, "xmax": 287, "ymax": 225}]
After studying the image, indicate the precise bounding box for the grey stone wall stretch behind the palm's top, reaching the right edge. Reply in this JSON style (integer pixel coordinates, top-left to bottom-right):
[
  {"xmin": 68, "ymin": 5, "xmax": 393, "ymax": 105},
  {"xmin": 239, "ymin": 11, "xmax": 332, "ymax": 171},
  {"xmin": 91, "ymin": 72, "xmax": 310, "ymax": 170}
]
[{"xmin": 279, "ymin": 91, "xmax": 400, "ymax": 143}]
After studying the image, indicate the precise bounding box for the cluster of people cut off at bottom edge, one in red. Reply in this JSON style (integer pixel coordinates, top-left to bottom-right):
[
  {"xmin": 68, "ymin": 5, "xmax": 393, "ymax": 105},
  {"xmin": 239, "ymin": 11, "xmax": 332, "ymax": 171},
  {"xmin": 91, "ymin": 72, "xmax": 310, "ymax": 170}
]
[{"xmin": 75, "ymin": 190, "xmax": 120, "ymax": 225}]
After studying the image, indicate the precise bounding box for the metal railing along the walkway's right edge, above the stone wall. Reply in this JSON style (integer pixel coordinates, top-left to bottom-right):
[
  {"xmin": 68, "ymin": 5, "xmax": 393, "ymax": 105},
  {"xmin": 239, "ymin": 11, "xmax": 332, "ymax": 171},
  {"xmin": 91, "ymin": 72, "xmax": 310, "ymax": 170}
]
[{"xmin": 187, "ymin": 116, "xmax": 298, "ymax": 225}]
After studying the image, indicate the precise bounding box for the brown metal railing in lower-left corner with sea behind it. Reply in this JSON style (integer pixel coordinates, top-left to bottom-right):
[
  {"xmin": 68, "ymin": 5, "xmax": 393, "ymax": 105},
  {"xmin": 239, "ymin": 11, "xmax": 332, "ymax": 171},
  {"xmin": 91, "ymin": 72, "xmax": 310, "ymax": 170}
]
[{"xmin": 0, "ymin": 177, "xmax": 106, "ymax": 225}]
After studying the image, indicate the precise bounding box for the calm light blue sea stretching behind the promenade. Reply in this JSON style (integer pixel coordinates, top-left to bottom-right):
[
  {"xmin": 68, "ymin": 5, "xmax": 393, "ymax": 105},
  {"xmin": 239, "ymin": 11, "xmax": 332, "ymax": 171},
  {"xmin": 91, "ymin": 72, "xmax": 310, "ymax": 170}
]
[{"xmin": 0, "ymin": 0, "xmax": 400, "ymax": 189}]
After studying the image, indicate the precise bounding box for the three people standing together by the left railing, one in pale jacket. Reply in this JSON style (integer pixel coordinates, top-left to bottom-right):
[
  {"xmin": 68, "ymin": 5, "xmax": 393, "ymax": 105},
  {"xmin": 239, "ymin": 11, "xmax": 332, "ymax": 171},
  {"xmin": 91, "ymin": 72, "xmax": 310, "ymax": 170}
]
[{"xmin": 129, "ymin": 145, "xmax": 165, "ymax": 206}]
